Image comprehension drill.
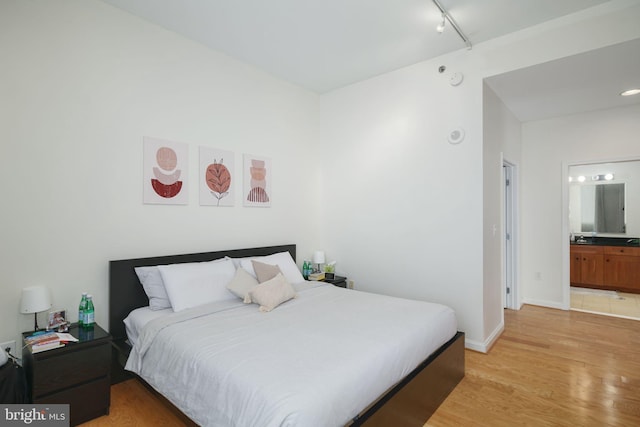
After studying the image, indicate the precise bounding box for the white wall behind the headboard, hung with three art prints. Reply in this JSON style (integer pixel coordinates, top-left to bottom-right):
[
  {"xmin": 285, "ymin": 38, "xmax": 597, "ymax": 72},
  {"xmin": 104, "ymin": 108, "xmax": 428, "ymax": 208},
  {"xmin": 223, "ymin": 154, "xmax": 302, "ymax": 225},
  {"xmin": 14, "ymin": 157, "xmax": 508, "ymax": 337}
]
[{"xmin": 0, "ymin": 0, "xmax": 318, "ymax": 342}]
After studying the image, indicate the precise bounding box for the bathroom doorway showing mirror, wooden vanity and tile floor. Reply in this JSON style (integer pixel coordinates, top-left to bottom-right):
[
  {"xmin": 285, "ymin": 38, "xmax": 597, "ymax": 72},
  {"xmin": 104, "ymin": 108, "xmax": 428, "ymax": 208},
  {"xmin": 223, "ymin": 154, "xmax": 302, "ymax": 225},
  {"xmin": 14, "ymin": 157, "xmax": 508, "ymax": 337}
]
[{"xmin": 563, "ymin": 158, "xmax": 640, "ymax": 319}]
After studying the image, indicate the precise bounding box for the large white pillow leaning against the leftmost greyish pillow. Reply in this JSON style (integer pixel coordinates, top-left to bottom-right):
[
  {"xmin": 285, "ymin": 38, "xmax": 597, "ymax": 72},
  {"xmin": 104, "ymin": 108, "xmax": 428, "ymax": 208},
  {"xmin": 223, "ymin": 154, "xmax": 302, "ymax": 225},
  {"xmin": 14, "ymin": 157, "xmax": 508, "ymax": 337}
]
[{"xmin": 158, "ymin": 259, "xmax": 236, "ymax": 311}]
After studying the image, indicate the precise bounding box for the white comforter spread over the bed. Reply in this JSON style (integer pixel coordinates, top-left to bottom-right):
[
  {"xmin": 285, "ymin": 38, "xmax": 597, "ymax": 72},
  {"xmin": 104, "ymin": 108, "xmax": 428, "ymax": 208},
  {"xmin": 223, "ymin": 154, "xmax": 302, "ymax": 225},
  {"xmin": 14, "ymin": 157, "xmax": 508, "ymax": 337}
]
[{"xmin": 126, "ymin": 283, "xmax": 456, "ymax": 426}]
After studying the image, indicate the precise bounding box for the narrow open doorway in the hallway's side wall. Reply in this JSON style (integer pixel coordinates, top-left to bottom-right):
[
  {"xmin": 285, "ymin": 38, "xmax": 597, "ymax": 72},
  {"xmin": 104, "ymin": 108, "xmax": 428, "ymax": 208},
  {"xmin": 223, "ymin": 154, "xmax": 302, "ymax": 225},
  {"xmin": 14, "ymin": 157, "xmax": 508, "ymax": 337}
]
[{"xmin": 502, "ymin": 160, "xmax": 520, "ymax": 310}]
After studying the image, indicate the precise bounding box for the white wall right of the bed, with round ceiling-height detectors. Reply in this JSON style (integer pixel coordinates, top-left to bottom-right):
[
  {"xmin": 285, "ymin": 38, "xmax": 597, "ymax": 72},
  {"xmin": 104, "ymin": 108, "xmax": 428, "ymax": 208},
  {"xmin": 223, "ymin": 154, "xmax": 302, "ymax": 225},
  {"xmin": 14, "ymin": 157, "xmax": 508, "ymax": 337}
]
[{"xmin": 319, "ymin": 1, "xmax": 640, "ymax": 351}]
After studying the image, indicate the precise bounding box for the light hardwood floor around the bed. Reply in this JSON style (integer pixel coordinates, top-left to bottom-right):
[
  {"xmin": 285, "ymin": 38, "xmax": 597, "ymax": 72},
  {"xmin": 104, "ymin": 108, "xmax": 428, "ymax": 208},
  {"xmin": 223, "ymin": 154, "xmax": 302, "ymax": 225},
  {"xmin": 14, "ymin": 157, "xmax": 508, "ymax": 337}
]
[{"xmin": 84, "ymin": 306, "xmax": 640, "ymax": 427}]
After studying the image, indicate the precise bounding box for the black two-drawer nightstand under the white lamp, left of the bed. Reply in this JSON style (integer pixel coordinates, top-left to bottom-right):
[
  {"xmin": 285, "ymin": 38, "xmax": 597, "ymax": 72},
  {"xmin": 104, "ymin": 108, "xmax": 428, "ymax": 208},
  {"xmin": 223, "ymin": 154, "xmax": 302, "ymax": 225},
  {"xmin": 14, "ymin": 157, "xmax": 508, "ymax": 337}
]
[{"xmin": 22, "ymin": 324, "xmax": 111, "ymax": 426}]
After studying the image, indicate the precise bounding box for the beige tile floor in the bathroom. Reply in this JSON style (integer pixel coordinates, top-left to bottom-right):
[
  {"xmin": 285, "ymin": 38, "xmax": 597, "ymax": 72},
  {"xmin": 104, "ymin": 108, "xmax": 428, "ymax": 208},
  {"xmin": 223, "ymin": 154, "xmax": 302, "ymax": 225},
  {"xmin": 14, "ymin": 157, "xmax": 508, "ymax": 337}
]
[{"xmin": 571, "ymin": 286, "xmax": 640, "ymax": 320}]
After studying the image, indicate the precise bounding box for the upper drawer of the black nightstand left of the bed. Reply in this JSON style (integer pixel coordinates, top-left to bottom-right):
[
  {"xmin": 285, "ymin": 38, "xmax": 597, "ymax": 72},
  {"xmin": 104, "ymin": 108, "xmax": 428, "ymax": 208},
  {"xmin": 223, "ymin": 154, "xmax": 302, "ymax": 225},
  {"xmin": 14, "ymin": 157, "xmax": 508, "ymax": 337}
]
[{"xmin": 33, "ymin": 342, "xmax": 111, "ymax": 401}]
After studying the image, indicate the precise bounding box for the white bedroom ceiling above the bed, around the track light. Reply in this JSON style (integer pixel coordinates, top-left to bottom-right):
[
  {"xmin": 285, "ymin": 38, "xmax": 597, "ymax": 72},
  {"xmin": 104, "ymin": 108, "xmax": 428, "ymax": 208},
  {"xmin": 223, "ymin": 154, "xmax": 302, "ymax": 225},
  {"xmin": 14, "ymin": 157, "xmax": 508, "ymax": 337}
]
[{"xmin": 103, "ymin": 0, "xmax": 608, "ymax": 93}]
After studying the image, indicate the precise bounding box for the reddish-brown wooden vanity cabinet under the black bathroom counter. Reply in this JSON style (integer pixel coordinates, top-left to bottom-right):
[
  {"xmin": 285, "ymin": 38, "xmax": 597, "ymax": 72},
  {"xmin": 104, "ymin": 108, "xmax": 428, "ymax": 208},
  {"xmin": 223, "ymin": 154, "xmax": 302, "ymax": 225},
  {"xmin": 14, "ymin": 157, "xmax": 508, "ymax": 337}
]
[{"xmin": 570, "ymin": 245, "xmax": 640, "ymax": 293}]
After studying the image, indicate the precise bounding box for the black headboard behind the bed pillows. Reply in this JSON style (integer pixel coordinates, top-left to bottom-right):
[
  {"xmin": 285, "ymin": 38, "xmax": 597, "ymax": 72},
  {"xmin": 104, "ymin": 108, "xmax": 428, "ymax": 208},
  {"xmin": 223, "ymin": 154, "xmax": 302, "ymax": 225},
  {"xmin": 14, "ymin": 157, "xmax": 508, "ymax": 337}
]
[{"xmin": 109, "ymin": 245, "xmax": 296, "ymax": 341}]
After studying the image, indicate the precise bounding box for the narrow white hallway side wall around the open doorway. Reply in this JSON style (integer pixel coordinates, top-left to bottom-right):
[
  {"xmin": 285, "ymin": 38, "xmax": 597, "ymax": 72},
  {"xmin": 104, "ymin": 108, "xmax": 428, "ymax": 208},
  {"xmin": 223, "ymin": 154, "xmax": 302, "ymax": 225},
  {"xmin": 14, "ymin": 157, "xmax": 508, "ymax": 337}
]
[{"xmin": 483, "ymin": 84, "xmax": 522, "ymax": 340}]
